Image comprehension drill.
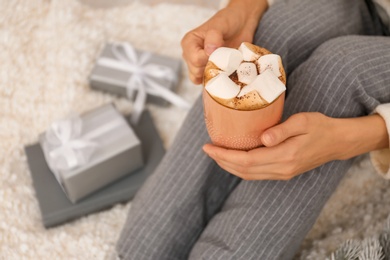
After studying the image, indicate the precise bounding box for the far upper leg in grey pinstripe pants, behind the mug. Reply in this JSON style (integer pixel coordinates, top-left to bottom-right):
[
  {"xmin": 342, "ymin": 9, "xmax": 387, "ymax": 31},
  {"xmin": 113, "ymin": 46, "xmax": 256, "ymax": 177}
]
[{"xmin": 254, "ymin": 0, "xmax": 368, "ymax": 73}]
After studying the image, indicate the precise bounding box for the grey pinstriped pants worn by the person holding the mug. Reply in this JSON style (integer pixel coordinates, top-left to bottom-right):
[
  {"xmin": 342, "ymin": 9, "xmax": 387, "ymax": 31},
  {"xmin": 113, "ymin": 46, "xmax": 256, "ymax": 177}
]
[{"xmin": 116, "ymin": 0, "xmax": 390, "ymax": 260}]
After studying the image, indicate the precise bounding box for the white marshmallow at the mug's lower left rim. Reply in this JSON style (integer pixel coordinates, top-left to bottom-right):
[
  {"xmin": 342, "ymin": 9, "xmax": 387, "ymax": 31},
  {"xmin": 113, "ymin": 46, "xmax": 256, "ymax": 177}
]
[{"xmin": 205, "ymin": 73, "xmax": 240, "ymax": 99}]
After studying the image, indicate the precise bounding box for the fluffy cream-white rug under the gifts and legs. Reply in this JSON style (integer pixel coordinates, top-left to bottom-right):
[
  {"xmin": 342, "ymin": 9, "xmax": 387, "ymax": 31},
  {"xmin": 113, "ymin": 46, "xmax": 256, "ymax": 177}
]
[{"xmin": 0, "ymin": 0, "xmax": 390, "ymax": 259}]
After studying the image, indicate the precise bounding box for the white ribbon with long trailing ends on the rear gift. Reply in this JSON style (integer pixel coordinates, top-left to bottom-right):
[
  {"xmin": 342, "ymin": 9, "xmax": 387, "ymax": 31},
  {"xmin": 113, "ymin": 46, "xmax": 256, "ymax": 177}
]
[{"xmin": 98, "ymin": 43, "xmax": 190, "ymax": 123}]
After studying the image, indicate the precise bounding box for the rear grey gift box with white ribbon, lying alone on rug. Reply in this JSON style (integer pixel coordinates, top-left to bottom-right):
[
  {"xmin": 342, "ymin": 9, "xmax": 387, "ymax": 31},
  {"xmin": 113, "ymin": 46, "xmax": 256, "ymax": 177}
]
[{"xmin": 90, "ymin": 43, "xmax": 186, "ymax": 106}]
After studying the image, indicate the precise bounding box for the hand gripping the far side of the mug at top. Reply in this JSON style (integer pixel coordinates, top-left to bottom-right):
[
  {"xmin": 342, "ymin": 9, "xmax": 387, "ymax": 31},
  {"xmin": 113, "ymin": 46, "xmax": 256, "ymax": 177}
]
[{"xmin": 181, "ymin": 0, "xmax": 268, "ymax": 84}]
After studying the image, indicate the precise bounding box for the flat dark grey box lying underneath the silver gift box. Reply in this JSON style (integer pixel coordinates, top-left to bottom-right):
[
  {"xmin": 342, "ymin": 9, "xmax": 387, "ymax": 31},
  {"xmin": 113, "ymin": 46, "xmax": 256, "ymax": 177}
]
[{"xmin": 25, "ymin": 110, "xmax": 165, "ymax": 228}]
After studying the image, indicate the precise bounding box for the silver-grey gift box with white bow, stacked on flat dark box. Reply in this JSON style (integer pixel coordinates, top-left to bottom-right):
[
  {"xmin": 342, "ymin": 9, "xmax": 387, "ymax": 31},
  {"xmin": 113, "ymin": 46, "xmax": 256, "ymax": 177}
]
[{"xmin": 39, "ymin": 104, "xmax": 143, "ymax": 203}]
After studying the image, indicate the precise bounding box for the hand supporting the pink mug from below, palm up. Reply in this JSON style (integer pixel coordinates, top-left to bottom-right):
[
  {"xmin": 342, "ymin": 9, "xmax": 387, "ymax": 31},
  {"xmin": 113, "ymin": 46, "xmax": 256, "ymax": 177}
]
[{"xmin": 203, "ymin": 113, "xmax": 389, "ymax": 180}]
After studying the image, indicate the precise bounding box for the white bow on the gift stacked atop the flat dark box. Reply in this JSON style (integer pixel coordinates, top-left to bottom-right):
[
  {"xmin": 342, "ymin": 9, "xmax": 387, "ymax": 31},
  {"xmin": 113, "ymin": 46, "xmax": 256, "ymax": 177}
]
[{"xmin": 45, "ymin": 116, "xmax": 97, "ymax": 170}]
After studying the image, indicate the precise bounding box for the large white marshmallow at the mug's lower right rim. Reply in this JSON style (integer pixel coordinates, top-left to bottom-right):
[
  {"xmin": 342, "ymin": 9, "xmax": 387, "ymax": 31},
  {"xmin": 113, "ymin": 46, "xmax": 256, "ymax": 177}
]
[{"xmin": 248, "ymin": 70, "xmax": 286, "ymax": 103}]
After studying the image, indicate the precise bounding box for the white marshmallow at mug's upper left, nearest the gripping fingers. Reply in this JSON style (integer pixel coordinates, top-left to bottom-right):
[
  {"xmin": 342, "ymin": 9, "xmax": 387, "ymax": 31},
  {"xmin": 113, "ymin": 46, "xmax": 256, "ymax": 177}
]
[{"xmin": 209, "ymin": 47, "xmax": 243, "ymax": 75}]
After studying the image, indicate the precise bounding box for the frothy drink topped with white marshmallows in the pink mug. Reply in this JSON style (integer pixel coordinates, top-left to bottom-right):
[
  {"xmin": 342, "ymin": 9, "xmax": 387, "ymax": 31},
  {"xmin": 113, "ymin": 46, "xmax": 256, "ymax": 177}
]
[{"xmin": 203, "ymin": 42, "xmax": 286, "ymax": 110}]
